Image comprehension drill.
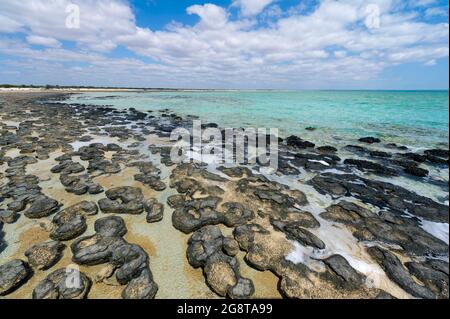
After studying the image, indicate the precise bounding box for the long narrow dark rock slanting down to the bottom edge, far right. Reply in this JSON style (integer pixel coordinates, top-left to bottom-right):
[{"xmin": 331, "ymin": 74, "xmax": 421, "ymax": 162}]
[{"xmin": 367, "ymin": 246, "xmax": 436, "ymax": 299}]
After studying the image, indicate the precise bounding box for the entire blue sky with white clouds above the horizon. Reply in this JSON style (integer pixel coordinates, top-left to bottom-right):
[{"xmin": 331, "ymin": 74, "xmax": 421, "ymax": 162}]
[{"xmin": 0, "ymin": 0, "xmax": 449, "ymax": 90}]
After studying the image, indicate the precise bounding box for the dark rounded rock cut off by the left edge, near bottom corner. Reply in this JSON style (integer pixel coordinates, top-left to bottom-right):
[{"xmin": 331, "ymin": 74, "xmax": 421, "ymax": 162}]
[{"xmin": 0, "ymin": 259, "xmax": 32, "ymax": 296}]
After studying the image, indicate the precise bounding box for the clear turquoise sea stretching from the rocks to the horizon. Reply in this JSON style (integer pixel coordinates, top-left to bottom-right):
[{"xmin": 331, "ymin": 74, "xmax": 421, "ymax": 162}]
[{"xmin": 67, "ymin": 91, "xmax": 449, "ymax": 148}]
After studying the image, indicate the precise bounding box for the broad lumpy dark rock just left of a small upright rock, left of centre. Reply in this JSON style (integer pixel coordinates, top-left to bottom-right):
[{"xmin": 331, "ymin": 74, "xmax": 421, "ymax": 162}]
[{"xmin": 98, "ymin": 186, "xmax": 144, "ymax": 215}]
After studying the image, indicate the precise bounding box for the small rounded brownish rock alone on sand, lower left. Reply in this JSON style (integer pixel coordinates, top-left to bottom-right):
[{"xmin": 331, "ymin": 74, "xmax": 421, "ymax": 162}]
[{"xmin": 25, "ymin": 241, "xmax": 65, "ymax": 270}]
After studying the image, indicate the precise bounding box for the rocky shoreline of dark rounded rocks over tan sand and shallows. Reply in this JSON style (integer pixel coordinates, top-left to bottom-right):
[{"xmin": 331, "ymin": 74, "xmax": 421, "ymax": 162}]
[{"xmin": 0, "ymin": 93, "xmax": 449, "ymax": 299}]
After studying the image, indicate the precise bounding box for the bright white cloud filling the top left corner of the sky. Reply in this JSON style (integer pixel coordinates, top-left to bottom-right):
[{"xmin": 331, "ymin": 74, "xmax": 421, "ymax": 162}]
[{"xmin": 0, "ymin": 0, "xmax": 135, "ymax": 51}]
